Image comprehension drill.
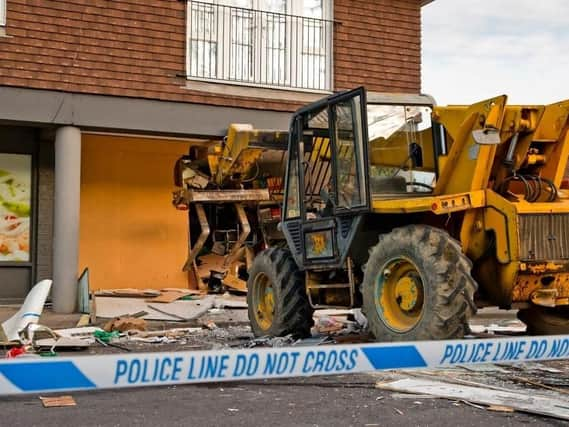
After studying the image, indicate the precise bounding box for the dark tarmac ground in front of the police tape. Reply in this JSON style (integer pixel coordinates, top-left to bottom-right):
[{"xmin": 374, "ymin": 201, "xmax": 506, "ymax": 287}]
[{"xmin": 0, "ymin": 375, "xmax": 567, "ymax": 427}]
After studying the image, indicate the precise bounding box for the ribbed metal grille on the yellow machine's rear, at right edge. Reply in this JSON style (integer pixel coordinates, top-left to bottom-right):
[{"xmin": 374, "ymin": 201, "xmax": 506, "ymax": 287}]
[{"xmin": 519, "ymin": 214, "xmax": 569, "ymax": 261}]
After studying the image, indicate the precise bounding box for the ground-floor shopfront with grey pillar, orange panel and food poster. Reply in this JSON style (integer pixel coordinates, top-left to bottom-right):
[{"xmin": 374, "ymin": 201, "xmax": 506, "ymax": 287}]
[{"xmin": 0, "ymin": 87, "xmax": 290, "ymax": 313}]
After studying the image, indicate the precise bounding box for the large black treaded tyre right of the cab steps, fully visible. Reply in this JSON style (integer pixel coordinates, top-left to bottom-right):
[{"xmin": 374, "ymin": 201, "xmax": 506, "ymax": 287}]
[{"xmin": 362, "ymin": 225, "xmax": 477, "ymax": 341}]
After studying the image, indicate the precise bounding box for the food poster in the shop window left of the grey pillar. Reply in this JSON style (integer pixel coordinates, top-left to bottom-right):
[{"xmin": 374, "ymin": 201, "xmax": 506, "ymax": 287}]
[{"xmin": 0, "ymin": 153, "xmax": 32, "ymax": 262}]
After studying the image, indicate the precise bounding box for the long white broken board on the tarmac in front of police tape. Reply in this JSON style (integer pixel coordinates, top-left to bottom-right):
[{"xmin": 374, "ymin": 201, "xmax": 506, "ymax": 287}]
[{"xmin": 376, "ymin": 378, "xmax": 569, "ymax": 420}]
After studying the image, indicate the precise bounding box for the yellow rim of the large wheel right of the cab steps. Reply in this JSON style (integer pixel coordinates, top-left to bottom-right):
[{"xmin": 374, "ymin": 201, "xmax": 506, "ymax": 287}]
[{"xmin": 375, "ymin": 257, "xmax": 425, "ymax": 333}]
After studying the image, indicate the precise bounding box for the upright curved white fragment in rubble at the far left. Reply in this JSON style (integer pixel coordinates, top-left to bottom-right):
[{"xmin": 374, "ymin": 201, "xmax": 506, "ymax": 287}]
[{"xmin": 0, "ymin": 280, "xmax": 52, "ymax": 342}]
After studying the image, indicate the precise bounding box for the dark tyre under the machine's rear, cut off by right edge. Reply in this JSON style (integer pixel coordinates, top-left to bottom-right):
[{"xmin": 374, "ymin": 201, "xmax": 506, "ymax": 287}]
[{"xmin": 518, "ymin": 306, "xmax": 569, "ymax": 335}]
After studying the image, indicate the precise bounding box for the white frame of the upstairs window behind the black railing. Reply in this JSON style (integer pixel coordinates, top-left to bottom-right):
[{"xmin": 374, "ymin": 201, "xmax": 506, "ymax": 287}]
[{"xmin": 186, "ymin": 0, "xmax": 333, "ymax": 92}]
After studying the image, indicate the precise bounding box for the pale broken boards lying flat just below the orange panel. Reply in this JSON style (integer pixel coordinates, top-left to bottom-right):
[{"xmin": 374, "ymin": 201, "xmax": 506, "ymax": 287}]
[{"xmin": 95, "ymin": 295, "xmax": 215, "ymax": 321}]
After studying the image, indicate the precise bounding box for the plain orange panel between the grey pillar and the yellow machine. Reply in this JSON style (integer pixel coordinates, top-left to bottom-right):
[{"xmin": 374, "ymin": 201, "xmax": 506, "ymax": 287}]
[{"xmin": 79, "ymin": 134, "xmax": 193, "ymax": 289}]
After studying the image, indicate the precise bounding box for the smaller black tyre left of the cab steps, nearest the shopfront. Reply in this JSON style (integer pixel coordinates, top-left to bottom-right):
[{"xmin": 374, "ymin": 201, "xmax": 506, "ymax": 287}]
[{"xmin": 247, "ymin": 248, "xmax": 314, "ymax": 338}]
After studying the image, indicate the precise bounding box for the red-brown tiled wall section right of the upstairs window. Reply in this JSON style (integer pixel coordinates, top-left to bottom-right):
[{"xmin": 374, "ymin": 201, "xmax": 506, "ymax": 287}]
[{"xmin": 334, "ymin": 0, "xmax": 421, "ymax": 93}]
